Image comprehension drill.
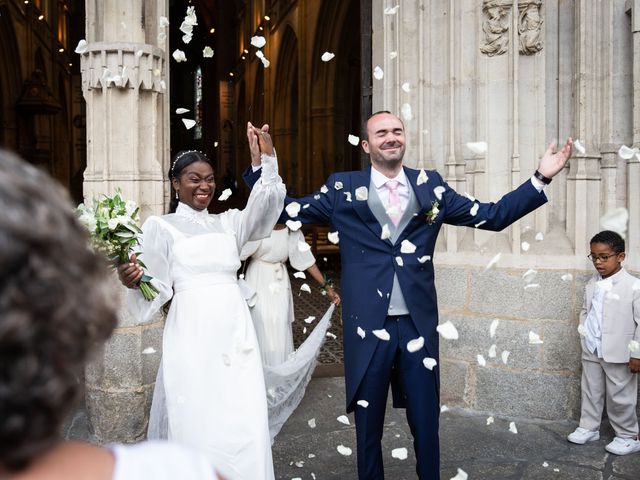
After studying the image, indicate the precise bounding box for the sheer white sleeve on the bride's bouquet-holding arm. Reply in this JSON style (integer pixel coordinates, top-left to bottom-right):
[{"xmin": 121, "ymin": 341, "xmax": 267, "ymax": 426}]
[{"xmin": 126, "ymin": 217, "xmax": 173, "ymax": 323}]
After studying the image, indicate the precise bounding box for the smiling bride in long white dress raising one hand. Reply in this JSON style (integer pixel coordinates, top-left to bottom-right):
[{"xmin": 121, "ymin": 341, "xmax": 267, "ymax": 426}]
[{"xmin": 119, "ymin": 124, "xmax": 285, "ymax": 480}]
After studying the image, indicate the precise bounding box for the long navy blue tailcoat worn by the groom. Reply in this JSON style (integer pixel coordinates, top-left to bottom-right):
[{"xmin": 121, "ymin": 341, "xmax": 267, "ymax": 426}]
[{"xmin": 244, "ymin": 163, "xmax": 547, "ymax": 412}]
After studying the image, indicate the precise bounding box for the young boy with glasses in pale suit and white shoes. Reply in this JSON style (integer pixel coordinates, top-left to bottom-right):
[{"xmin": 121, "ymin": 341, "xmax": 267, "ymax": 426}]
[{"xmin": 567, "ymin": 230, "xmax": 640, "ymax": 455}]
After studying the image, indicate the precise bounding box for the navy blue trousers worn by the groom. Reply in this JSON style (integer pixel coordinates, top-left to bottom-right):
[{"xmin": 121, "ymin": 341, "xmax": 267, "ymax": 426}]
[{"xmin": 355, "ymin": 315, "xmax": 440, "ymax": 480}]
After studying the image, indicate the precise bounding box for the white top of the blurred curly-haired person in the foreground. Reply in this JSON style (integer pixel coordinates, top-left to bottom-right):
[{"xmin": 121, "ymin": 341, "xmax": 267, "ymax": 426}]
[{"xmin": 107, "ymin": 442, "xmax": 218, "ymax": 480}]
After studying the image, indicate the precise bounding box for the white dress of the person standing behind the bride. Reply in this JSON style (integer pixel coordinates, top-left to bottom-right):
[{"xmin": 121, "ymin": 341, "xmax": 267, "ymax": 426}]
[{"xmin": 241, "ymin": 228, "xmax": 315, "ymax": 366}]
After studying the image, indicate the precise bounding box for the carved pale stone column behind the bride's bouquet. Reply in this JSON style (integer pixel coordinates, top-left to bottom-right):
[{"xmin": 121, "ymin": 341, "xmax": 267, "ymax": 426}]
[{"xmin": 81, "ymin": 0, "xmax": 169, "ymax": 442}]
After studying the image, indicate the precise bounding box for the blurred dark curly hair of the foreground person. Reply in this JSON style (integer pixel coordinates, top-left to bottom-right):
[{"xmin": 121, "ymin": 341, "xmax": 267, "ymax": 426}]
[{"xmin": 0, "ymin": 150, "xmax": 117, "ymax": 471}]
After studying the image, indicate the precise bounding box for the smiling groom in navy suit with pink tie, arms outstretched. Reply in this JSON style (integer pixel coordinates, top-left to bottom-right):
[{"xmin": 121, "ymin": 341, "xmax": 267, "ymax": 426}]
[{"xmin": 245, "ymin": 111, "xmax": 572, "ymax": 480}]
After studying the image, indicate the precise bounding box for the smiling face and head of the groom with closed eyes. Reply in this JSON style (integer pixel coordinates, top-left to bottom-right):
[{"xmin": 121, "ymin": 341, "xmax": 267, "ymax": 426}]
[{"xmin": 362, "ymin": 113, "xmax": 405, "ymax": 168}]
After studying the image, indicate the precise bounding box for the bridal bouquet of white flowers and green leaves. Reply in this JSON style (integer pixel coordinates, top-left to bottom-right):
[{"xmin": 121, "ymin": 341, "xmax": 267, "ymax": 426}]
[{"xmin": 76, "ymin": 190, "xmax": 158, "ymax": 300}]
